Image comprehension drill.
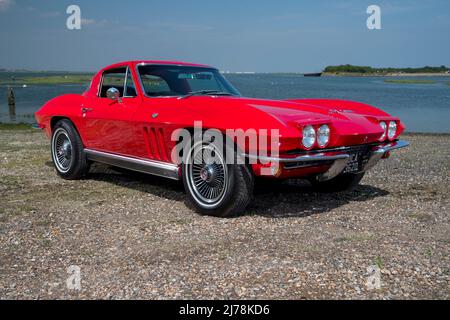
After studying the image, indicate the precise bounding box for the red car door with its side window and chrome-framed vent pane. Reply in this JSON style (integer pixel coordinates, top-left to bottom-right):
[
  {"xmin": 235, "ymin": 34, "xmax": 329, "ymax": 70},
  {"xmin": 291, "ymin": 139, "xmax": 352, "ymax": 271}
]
[{"xmin": 82, "ymin": 66, "xmax": 141, "ymax": 155}]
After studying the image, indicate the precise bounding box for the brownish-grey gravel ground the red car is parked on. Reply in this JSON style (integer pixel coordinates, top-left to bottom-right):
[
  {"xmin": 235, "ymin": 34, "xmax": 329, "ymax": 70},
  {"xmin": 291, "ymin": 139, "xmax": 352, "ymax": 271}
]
[{"xmin": 0, "ymin": 130, "xmax": 450, "ymax": 299}]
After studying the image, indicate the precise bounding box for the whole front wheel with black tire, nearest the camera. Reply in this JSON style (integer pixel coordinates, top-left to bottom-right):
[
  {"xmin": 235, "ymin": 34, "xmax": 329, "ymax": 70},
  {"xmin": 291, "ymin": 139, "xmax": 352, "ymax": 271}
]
[{"xmin": 182, "ymin": 135, "xmax": 254, "ymax": 217}]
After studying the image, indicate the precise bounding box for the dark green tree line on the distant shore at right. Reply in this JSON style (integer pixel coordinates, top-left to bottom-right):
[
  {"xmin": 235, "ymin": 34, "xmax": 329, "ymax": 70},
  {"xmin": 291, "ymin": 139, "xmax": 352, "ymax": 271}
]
[{"xmin": 323, "ymin": 64, "xmax": 450, "ymax": 73}]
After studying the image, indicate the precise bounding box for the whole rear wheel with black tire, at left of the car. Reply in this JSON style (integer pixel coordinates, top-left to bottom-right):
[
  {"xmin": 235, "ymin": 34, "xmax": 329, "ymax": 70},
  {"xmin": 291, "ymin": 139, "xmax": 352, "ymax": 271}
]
[{"xmin": 51, "ymin": 119, "xmax": 90, "ymax": 180}]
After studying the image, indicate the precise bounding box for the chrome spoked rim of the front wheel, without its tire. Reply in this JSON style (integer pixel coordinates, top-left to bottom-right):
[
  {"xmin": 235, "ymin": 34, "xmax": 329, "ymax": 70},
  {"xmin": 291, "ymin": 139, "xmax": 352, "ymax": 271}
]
[{"xmin": 187, "ymin": 144, "xmax": 228, "ymax": 208}]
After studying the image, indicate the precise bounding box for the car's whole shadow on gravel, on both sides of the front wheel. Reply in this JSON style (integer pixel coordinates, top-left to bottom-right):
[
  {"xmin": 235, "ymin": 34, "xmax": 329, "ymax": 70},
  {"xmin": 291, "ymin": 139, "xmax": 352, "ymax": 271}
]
[{"xmin": 68, "ymin": 164, "xmax": 389, "ymax": 218}]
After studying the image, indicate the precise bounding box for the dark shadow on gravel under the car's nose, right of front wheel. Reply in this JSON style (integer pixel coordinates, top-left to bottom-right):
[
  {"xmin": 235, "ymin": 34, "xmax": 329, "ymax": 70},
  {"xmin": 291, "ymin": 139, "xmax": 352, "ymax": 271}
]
[{"xmin": 247, "ymin": 180, "xmax": 389, "ymax": 218}]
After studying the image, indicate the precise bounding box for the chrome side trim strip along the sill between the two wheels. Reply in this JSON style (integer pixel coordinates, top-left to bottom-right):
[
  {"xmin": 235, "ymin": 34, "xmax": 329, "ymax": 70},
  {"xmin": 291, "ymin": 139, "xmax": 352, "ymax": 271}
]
[{"xmin": 84, "ymin": 149, "xmax": 180, "ymax": 180}]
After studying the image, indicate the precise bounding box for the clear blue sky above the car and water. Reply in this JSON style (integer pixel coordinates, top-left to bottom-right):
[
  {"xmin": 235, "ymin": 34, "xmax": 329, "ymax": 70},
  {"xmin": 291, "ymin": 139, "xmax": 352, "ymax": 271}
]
[{"xmin": 0, "ymin": 0, "xmax": 450, "ymax": 72}]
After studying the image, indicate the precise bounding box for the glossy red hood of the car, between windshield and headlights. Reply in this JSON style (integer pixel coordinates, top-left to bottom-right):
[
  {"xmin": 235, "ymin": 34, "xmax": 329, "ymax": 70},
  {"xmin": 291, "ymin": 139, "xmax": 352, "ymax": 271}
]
[{"xmin": 183, "ymin": 97, "xmax": 403, "ymax": 144}]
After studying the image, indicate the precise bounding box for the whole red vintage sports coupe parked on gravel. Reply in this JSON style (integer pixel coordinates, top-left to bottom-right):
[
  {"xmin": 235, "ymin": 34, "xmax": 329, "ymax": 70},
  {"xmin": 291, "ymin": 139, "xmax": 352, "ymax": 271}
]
[{"xmin": 36, "ymin": 61, "xmax": 408, "ymax": 217}]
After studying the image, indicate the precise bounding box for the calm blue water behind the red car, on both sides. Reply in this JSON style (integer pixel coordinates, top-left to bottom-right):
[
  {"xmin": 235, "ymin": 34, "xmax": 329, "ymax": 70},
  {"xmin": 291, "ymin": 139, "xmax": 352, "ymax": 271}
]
[{"xmin": 0, "ymin": 74, "xmax": 450, "ymax": 133}]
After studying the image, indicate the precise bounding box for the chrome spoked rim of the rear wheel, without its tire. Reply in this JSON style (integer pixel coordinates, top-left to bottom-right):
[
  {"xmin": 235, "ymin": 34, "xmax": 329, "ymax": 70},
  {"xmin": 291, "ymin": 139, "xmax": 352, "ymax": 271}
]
[{"xmin": 52, "ymin": 128, "xmax": 73, "ymax": 173}]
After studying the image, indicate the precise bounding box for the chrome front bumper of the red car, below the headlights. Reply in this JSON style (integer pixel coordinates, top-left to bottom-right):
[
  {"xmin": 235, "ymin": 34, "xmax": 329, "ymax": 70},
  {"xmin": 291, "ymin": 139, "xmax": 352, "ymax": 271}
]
[{"xmin": 246, "ymin": 140, "xmax": 409, "ymax": 181}]
